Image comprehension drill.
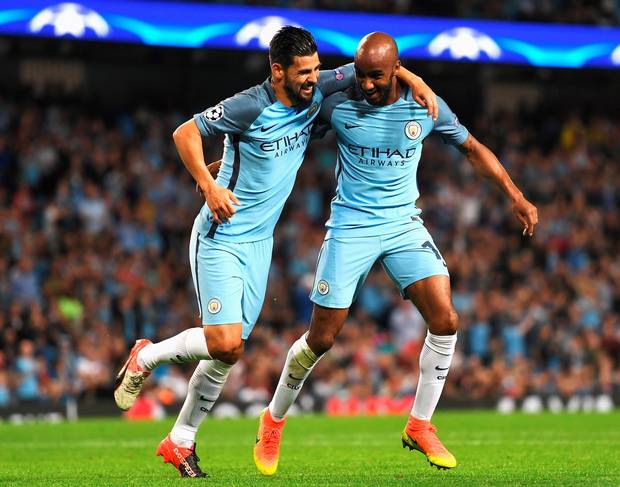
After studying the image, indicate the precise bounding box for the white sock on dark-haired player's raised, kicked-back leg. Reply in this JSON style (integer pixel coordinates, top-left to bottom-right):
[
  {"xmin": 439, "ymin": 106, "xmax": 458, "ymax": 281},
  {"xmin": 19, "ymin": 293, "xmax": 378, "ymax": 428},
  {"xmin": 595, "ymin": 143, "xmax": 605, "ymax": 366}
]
[{"xmin": 138, "ymin": 327, "xmax": 211, "ymax": 370}]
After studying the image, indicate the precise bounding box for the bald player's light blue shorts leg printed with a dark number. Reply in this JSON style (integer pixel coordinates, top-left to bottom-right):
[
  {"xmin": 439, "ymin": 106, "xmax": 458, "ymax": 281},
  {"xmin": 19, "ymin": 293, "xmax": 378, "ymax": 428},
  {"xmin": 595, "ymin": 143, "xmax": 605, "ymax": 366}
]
[{"xmin": 381, "ymin": 227, "xmax": 449, "ymax": 296}]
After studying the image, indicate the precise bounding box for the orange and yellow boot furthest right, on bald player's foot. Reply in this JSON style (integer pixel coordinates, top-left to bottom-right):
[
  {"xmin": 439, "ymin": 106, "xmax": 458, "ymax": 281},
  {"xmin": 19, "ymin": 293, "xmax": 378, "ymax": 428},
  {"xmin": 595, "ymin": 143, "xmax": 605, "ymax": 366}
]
[{"xmin": 401, "ymin": 416, "xmax": 456, "ymax": 470}]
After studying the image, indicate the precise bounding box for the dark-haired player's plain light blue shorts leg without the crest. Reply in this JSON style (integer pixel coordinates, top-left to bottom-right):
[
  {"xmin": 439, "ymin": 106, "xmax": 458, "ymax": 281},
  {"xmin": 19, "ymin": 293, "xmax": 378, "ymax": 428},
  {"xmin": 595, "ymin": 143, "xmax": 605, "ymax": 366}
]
[{"xmin": 241, "ymin": 238, "xmax": 273, "ymax": 340}]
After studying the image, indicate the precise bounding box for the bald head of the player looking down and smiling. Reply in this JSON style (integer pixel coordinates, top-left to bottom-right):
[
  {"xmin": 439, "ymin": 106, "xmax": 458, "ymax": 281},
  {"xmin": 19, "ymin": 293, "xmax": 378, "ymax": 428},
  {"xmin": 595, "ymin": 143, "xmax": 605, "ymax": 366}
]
[{"xmin": 355, "ymin": 32, "xmax": 400, "ymax": 105}]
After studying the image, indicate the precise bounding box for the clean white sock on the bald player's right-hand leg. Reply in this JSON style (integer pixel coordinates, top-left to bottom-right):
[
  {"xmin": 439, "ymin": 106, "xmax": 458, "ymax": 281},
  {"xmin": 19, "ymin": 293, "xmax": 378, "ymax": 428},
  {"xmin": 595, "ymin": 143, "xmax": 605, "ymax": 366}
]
[{"xmin": 411, "ymin": 331, "xmax": 456, "ymax": 421}]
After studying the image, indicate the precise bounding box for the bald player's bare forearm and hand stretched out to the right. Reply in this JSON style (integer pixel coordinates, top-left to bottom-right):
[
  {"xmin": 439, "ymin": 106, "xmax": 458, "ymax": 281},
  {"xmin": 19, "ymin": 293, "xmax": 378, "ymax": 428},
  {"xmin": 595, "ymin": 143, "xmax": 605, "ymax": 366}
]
[{"xmin": 459, "ymin": 134, "xmax": 538, "ymax": 237}]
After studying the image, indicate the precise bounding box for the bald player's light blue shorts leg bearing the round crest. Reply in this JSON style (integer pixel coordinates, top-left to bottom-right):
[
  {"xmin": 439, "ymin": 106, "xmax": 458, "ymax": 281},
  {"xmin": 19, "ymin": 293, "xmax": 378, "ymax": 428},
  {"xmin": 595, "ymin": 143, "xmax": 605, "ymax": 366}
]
[{"xmin": 310, "ymin": 237, "xmax": 380, "ymax": 309}]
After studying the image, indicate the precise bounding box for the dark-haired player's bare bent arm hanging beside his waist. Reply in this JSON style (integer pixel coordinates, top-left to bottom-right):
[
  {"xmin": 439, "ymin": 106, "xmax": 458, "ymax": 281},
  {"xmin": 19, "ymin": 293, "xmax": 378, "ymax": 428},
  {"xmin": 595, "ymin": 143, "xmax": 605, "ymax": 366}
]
[{"xmin": 172, "ymin": 119, "xmax": 239, "ymax": 224}]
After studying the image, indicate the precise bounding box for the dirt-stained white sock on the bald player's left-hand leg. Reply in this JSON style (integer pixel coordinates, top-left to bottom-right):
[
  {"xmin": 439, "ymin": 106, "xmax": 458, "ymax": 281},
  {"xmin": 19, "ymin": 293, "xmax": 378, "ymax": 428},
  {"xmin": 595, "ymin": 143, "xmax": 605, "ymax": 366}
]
[{"xmin": 269, "ymin": 333, "xmax": 322, "ymax": 420}]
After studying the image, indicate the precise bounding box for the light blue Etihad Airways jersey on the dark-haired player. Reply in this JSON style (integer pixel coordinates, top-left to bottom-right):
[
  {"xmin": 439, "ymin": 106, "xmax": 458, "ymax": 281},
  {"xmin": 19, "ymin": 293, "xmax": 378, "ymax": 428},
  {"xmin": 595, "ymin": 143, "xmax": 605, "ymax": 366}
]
[{"xmin": 194, "ymin": 64, "xmax": 355, "ymax": 242}]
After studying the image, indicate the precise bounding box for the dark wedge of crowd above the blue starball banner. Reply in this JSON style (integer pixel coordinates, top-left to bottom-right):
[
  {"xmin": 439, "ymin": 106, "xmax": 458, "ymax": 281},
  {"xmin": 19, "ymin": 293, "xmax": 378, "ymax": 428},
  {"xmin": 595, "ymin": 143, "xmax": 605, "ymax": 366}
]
[{"xmin": 213, "ymin": 0, "xmax": 620, "ymax": 25}]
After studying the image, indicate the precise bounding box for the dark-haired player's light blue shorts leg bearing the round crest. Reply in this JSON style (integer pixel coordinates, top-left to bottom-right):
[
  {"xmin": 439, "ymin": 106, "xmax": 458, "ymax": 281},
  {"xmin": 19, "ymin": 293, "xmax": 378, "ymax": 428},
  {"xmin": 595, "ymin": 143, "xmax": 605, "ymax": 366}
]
[{"xmin": 190, "ymin": 232, "xmax": 244, "ymax": 326}]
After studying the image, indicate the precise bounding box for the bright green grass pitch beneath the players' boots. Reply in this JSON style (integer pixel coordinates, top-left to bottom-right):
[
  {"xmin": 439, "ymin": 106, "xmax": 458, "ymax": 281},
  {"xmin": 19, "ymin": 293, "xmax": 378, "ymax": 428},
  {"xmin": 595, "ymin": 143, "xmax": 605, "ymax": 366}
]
[{"xmin": 0, "ymin": 412, "xmax": 620, "ymax": 487}]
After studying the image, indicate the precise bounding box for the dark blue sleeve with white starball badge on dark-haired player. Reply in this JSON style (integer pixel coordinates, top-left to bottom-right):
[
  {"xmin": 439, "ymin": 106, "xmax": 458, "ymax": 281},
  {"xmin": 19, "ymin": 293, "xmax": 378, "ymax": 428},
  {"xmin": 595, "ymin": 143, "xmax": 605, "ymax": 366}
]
[{"xmin": 194, "ymin": 93, "xmax": 262, "ymax": 137}]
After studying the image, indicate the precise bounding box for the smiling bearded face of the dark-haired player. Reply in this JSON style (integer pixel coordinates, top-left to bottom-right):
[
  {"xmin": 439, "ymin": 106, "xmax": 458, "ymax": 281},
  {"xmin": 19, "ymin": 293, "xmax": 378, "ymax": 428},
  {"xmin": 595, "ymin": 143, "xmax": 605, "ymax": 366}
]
[{"xmin": 271, "ymin": 52, "xmax": 321, "ymax": 105}]
